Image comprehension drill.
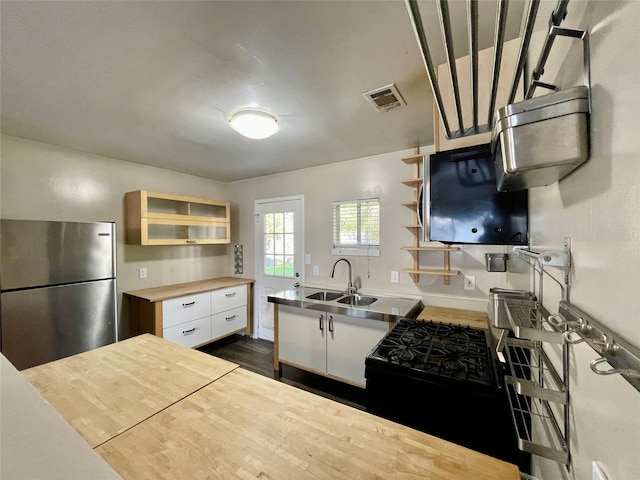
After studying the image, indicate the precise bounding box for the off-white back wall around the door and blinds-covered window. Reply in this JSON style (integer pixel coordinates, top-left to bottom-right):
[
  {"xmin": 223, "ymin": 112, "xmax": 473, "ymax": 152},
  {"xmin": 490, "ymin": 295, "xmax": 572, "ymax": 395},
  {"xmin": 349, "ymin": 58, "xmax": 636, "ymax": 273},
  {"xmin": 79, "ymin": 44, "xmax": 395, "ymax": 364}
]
[{"xmin": 230, "ymin": 149, "xmax": 528, "ymax": 310}]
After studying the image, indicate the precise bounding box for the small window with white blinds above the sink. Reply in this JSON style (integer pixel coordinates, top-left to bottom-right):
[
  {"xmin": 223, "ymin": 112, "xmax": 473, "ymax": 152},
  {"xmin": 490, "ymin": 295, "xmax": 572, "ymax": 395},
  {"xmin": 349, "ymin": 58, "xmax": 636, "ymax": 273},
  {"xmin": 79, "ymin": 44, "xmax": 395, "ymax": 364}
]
[{"xmin": 333, "ymin": 198, "xmax": 380, "ymax": 256}]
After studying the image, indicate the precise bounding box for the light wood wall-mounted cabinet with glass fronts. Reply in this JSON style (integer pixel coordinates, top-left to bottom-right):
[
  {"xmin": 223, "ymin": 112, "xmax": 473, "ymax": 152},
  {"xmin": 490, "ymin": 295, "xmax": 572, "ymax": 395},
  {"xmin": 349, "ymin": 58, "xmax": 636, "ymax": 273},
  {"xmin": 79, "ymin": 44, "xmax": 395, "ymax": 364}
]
[{"xmin": 125, "ymin": 190, "xmax": 231, "ymax": 245}]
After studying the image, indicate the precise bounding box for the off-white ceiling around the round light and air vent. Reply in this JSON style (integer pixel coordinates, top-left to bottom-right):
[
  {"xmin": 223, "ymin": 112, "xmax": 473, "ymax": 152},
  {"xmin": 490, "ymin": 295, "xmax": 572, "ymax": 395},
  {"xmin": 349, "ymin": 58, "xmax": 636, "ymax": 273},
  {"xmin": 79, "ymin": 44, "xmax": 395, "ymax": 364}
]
[{"xmin": 0, "ymin": 0, "xmax": 522, "ymax": 182}]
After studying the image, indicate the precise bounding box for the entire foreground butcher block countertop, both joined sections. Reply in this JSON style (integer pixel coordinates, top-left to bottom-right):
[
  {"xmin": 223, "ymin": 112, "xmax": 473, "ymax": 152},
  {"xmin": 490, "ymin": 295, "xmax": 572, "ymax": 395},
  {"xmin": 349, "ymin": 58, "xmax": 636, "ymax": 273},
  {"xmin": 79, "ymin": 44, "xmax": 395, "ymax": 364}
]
[{"xmin": 24, "ymin": 334, "xmax": 519, "ymax": 480}]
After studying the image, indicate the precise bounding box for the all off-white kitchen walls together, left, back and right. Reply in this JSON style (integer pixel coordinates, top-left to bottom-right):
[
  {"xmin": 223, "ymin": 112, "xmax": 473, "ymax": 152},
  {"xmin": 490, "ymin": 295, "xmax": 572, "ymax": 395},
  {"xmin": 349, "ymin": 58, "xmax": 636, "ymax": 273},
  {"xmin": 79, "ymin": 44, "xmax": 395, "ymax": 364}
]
[{"xmin": 0, "ymin": 0, "xmax": 640, "ymax": 480}]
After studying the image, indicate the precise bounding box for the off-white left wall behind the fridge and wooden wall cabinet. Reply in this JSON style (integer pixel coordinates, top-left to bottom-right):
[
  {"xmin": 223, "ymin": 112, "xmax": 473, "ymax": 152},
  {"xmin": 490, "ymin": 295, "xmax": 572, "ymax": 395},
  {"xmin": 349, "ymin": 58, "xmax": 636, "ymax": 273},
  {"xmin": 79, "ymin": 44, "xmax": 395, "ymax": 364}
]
[{"xmin": 0, "ymin": 135, "xmax": 233, "ymax": 337}]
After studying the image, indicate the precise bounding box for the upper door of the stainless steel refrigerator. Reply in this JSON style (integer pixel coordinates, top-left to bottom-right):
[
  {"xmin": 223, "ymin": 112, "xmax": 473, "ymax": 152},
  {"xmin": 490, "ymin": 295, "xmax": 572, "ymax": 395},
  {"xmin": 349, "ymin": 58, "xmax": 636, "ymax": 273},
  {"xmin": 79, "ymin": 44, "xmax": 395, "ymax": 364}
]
[{"xmin": 0, "ymin": 220, "xmax": 115, "ymax": 291}]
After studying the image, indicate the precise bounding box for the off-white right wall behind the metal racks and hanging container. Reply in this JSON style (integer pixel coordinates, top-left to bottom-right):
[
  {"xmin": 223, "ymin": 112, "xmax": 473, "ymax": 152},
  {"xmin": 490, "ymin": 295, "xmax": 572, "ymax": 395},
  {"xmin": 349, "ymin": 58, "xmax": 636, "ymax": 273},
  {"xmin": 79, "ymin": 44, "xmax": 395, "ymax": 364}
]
[{"xmin": 516, "ymin": 0, "xmax": 640, "ymax": 480}]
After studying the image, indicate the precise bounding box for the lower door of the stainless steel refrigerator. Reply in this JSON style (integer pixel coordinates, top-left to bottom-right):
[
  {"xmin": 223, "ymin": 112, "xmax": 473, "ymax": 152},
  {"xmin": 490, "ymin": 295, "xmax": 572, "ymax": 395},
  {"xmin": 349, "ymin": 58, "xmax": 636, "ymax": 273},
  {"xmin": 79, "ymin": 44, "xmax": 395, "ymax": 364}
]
[{"xmin": 1, "ymin": 280, "xmax": 117, "ymax": 370}]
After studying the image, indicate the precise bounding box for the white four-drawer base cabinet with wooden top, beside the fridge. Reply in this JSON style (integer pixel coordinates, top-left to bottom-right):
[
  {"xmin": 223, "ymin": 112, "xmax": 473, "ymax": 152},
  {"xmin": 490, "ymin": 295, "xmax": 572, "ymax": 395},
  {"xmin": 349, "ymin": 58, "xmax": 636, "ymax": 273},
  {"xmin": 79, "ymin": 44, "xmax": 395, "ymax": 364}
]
[{"xmin": 125, "ymin": 277, "xmax": 253, "ymax": 347}]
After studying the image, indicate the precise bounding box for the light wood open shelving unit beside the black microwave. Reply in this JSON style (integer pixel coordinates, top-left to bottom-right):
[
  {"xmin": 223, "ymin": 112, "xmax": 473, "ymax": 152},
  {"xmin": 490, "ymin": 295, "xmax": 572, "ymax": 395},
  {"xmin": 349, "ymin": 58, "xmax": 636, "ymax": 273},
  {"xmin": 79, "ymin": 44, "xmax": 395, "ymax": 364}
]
[{"xmin": 401, "ymin": 148, "xmax": 460, "ymax": 285}]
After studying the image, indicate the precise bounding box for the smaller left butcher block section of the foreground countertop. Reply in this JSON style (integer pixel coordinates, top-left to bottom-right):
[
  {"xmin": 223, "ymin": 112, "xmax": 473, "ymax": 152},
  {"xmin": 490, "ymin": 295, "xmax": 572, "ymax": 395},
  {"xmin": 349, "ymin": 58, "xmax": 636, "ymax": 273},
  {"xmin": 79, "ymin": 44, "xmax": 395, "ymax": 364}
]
[{"xmin": 21, "ymin": 334, "xmax": 238, "ymax": 447}]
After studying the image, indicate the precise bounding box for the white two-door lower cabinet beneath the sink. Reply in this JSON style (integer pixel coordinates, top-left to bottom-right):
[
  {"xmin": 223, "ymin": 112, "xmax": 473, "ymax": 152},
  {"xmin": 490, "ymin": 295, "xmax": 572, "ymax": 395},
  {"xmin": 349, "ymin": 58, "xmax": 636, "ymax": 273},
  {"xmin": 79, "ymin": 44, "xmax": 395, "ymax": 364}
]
[{"xmin": 278, "ymin": 305, "xmax": 389, "ymax": 386}]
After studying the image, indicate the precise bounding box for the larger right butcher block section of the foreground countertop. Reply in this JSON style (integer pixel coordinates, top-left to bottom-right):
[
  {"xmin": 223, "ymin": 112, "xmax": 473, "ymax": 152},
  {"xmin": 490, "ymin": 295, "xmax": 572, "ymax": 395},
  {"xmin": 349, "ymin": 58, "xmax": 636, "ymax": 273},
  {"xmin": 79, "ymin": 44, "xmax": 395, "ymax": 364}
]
[{"xmin": 96, "ymin": 368, "xmax": 519, "ymax": 480}]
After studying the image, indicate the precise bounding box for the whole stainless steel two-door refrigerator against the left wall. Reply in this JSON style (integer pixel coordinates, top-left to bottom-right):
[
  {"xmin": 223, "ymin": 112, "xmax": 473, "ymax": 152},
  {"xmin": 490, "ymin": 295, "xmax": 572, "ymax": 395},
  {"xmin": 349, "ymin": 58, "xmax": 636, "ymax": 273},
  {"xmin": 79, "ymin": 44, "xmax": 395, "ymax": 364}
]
[{"xmin": 0, "ymin": 220, "xmax": 118, "ymax": 370}]
